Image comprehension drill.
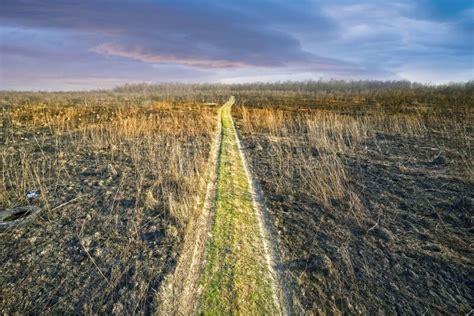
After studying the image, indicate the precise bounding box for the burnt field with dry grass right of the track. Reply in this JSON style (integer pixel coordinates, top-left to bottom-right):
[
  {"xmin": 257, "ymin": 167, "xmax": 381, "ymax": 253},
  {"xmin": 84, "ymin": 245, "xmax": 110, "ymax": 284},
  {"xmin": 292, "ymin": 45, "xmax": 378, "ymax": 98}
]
[{"xmin": 234, "ymin": 91, "xmax": 474, "ymax": 314}]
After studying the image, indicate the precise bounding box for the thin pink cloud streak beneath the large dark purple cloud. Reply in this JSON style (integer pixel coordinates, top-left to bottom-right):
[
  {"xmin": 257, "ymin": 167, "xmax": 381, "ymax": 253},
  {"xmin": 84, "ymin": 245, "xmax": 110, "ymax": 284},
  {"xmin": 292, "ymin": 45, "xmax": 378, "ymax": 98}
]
[{"xmin": 92, "ymin": 44, "xmax": 253, "ymax": 68}]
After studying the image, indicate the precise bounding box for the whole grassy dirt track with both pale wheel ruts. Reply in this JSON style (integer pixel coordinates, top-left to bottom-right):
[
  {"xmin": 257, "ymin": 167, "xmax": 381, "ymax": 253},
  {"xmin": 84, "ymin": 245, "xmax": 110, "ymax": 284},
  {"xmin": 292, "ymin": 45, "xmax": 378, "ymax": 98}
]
[{"xmin": 160, "ymin": 97, "xmax": 287, "ymax": 315}]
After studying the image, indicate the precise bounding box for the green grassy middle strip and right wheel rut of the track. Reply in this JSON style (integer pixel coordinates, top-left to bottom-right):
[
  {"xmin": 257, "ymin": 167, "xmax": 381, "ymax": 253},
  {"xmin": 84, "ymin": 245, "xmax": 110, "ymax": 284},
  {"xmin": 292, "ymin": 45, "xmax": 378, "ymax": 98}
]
[{"xmin": 199, "ymin": 97, "xmax": 281, "ymax": 315}]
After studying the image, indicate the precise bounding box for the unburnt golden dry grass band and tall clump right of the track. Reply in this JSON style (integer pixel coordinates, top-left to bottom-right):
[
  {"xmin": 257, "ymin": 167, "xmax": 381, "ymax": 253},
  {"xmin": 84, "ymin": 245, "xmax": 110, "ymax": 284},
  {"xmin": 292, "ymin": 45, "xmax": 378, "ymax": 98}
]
[{"xmin": 236, "ymin": 102, "xmax": 473, "ymax": 206}]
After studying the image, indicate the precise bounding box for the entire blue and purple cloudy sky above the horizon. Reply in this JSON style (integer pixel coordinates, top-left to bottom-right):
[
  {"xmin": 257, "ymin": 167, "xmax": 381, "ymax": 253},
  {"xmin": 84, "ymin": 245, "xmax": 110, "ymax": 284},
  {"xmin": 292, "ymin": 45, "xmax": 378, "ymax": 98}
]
[{"xmin": 0, "ymin": 0, "xmax": 474, "ymax": 90}]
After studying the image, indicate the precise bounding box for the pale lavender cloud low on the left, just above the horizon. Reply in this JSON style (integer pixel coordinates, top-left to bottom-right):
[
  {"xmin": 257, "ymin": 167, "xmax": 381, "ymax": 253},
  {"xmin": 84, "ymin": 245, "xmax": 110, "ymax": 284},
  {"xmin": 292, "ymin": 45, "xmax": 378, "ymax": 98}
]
[{"xmin": 0, "ymin": 28, "xmax": 211, "ymax": 90}]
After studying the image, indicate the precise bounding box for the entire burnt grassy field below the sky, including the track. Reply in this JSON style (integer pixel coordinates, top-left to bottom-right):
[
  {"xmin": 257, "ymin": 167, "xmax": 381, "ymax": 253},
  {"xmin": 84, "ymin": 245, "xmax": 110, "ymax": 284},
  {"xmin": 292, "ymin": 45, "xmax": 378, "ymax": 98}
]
[{"xmin": 0, "ymin": 82, "xmax": 474, "ymax": 314}]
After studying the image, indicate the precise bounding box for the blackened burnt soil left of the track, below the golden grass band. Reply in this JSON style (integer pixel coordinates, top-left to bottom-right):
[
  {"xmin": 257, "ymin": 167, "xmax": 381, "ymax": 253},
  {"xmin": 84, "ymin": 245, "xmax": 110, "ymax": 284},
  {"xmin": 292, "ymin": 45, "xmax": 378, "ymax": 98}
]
[{"xmin": 0, "ymin": 100, "xmax": 215, "ymax": 314}]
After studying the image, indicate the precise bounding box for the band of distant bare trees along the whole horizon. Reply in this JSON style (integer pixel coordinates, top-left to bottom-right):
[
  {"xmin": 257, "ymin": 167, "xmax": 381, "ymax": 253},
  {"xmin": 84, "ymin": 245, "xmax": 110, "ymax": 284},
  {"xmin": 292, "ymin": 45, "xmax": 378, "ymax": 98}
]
[{"xmin": 0, "ymin": 80, "xmax": 474, "ymax": 108}]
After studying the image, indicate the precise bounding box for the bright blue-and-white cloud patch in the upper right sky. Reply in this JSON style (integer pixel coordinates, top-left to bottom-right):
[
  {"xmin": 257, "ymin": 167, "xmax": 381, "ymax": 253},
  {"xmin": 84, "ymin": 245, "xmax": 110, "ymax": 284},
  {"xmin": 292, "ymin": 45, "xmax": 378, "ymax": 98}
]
[{"xmin": 323, "ymin": 1, "xmax": 474, "ymax": 71}]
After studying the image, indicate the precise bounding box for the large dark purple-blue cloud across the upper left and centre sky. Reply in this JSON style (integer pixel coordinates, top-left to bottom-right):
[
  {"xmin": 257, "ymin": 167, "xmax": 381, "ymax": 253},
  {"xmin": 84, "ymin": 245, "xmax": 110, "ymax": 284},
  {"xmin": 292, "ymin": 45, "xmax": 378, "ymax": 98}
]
[{"xmin": 1, "ymin": 0, "xmax": 340, "ymax": 67}]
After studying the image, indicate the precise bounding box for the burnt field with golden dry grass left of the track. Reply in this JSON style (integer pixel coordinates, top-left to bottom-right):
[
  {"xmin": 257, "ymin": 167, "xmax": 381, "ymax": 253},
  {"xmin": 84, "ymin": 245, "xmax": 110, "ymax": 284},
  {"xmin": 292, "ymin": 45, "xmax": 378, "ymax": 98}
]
[{"xmin": 0, "ymin": 93, "xmax": 216, "ymax": 314}]
